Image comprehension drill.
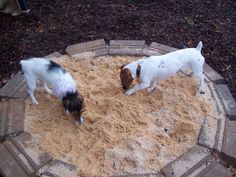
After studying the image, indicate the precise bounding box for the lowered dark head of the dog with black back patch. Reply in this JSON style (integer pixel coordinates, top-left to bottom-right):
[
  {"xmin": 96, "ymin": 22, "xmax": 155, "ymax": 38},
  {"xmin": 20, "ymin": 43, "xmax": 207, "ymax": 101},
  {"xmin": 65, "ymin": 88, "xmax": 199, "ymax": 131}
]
[{"xmin": 62, "ymin": 92, "xmax": 84, "ymax": 124}]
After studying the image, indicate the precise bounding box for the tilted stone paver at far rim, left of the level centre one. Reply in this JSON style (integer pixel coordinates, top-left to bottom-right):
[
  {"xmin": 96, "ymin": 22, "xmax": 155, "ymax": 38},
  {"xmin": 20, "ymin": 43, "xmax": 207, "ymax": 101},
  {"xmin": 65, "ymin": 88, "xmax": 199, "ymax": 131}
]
[{"xmin": 66, "ymin": 39, "xmax": 108, "ymax": 59}]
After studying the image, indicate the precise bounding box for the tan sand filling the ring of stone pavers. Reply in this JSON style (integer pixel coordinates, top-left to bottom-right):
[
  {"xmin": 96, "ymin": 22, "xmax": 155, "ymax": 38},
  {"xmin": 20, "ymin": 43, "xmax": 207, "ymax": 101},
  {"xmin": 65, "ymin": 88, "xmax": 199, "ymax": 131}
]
[{"xmin": 25, "ymin": 56, "xmax": 217, "ymax": 176}]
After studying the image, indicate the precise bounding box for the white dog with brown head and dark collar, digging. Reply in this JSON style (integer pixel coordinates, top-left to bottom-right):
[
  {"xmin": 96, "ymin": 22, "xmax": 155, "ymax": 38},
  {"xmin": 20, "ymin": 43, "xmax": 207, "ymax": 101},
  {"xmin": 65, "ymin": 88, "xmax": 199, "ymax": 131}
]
[{"xmin": 120, "ymin": 41, "xmax": 205, "ymax": 95}]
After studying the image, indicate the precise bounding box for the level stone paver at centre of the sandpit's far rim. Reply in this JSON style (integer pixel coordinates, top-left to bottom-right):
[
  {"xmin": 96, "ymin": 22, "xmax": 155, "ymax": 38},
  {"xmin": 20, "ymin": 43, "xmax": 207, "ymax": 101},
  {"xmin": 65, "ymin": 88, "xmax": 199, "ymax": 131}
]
[{"xmin": 108, "ymin": 40, "xmax": 145, "ymax": 56}]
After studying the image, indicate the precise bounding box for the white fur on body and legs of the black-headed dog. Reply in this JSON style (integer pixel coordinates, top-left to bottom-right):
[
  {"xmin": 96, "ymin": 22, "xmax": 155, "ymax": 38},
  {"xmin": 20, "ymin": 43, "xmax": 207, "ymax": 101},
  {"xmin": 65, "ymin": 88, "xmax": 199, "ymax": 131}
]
[{"xmin": 20, "ymin": 58, "xmax": 77, "ymax": 104}]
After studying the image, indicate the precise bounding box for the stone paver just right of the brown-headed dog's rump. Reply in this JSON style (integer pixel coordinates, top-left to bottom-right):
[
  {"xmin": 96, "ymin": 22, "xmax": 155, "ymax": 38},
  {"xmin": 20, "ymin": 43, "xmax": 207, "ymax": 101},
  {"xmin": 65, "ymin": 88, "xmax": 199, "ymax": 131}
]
[{"xmin": 203, "ymin": 63, "xmax": 224, "ymax": 84}]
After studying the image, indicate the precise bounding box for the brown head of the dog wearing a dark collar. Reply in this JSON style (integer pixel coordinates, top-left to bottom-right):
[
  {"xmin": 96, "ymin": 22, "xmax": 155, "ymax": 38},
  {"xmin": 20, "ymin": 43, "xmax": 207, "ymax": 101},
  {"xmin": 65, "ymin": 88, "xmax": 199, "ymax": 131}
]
[{"xmin": 120, "ymin": 65, "xmax": 134, "ymax": 90}]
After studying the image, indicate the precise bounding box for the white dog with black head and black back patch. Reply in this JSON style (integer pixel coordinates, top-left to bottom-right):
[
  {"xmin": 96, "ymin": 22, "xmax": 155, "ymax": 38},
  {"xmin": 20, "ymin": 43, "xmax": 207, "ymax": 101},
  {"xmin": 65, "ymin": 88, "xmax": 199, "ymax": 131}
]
[{"xmin": 20, "ymin": 58, "xmax": 84, "ymax": 124}]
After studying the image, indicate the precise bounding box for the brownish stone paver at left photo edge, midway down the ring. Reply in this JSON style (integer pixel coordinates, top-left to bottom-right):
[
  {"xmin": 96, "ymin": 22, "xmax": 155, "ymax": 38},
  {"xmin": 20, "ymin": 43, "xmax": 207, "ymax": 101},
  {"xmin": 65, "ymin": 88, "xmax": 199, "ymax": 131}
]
[{"xmin": 0, "ymin": 99, "xmax": 25, "ymax": 141}]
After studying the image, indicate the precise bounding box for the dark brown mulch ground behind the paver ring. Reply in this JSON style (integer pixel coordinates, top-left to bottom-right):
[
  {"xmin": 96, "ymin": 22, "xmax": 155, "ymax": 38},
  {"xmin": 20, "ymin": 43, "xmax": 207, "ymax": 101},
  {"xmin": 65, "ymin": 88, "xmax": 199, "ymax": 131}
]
[{"xmin": 0, "ymin": 0, "xmax": 236, "ymax": 98}]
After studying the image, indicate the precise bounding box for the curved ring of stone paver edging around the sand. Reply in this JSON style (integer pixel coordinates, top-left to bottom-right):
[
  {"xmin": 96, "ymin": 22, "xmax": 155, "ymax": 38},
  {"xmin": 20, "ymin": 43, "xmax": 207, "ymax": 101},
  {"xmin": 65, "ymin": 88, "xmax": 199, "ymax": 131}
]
[{"xmin": 0, "ymin": 39, "xmax": 236, "ymax": 177}]
